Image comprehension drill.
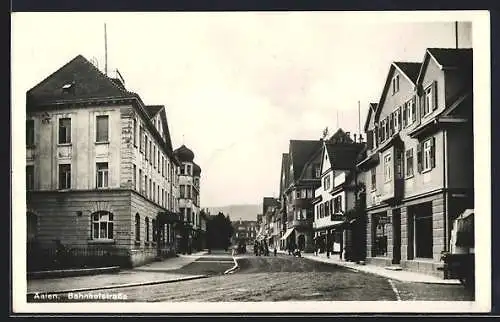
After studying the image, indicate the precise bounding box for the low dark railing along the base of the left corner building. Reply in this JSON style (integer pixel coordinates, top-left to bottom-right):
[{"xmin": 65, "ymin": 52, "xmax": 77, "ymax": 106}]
[{"xmin": 26, "ymin": 244, "xmax": 129, "ymax": 272}]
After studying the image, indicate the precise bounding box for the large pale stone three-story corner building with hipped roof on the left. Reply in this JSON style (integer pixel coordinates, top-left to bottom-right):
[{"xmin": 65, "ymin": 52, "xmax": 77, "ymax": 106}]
[{"xmin": 26, "ymin": 55, "xmax": 179, "ymax": 265}]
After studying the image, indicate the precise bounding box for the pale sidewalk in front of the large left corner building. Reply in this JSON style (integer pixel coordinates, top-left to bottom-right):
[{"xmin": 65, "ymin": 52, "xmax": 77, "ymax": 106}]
[{"xmin": 27, "ymin": 252, "xmax": 206, "ymax": 293}]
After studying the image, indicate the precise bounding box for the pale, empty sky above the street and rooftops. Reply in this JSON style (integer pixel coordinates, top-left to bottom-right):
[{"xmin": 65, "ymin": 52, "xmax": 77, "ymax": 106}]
[{"xmin": 12, "ymin": 12, "xmax": 472, "ymax": 207}]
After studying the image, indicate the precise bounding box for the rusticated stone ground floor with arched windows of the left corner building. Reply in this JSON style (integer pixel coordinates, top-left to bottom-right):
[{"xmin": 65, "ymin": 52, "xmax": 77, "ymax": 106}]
[{"xmin": 26, "ymin": 189, "xmax": 182, "ymax": 269}]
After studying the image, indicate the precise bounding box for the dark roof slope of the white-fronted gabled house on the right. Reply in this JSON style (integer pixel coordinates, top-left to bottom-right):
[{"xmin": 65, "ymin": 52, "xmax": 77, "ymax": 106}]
[{"xmin": 325, "ymin": 143, "xmax": 365, "ymax": 170}]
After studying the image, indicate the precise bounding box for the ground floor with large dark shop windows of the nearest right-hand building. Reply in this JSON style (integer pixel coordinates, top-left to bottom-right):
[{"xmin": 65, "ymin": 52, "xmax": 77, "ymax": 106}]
[{"xmin": 366, "ymin": 191, "xmax": 474, "ymax": 278}]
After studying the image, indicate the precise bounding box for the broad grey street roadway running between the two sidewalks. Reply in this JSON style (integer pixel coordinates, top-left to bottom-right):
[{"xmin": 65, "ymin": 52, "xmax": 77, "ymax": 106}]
[{"xmin": 33, "ymin": 251, "xmax": 473, "ymax": 302}]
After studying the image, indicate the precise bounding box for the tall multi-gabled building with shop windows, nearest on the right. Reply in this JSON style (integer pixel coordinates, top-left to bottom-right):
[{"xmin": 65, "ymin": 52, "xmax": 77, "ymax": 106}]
[{"xmin": 358, "ymin": 48, "xmax": 474, "ymax": 276}]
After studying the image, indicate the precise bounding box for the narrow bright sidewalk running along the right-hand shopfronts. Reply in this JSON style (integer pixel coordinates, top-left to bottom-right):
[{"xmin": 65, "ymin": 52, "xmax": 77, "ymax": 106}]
[{"xmin": 278, "ymin": 250, "xmax": 460, "ymax": 285}]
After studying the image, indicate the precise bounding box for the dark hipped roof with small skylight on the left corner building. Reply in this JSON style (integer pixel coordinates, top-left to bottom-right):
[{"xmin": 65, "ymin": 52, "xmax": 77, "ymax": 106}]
[{"xmin": 26, "ymin": 55, "xmax": 134, "ymax": 105}]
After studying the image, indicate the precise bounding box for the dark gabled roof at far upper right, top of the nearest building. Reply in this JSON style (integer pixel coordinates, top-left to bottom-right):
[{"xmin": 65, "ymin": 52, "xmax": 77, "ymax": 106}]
[{"xmin": 417, "ymin": 48, "xmax": 473, "ymax": 84}]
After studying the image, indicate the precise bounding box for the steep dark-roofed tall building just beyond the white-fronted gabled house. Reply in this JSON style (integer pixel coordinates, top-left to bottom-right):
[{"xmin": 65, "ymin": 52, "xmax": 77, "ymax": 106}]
[{"xmin": 280, "ymin": 140, "xmax": 323, "ymax": 252}]
